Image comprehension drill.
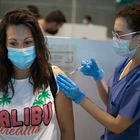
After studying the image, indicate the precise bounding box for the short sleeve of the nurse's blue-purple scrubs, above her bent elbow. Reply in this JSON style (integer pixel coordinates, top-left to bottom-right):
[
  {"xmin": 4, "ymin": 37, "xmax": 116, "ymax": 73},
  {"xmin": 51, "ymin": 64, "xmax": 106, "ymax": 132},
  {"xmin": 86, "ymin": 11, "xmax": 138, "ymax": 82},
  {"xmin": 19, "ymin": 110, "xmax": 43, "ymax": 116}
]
[{"xmin": 119, "ymin": 80, "xmax": 140, "ymax": 122}]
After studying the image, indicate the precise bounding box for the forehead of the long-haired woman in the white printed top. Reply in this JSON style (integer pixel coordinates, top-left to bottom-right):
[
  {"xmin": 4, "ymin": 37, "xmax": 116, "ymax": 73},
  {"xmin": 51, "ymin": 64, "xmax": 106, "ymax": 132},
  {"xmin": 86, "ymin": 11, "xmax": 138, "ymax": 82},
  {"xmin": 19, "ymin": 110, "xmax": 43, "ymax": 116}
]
[{"xmin": 6, "ymin": 25, "xmax": 32, "ymax": 38}]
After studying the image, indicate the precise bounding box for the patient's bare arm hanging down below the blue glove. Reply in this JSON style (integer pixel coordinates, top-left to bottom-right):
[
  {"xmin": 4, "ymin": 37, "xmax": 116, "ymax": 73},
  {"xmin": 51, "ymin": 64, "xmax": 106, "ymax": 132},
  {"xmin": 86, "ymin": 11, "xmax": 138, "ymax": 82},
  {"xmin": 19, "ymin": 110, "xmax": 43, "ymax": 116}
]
[{"xmin": 55, "ymin": 92, "xmax": 74, "ymax": 140}]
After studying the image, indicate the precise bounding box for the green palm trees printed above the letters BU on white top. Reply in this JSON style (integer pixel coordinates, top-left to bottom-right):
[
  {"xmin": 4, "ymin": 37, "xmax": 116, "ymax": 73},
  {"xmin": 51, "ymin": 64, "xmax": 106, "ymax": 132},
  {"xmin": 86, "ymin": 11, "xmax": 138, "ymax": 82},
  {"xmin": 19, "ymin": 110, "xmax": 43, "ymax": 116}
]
[{"xmin": 33, "ymin": 90, "xmax": 50, "ymax": 106}]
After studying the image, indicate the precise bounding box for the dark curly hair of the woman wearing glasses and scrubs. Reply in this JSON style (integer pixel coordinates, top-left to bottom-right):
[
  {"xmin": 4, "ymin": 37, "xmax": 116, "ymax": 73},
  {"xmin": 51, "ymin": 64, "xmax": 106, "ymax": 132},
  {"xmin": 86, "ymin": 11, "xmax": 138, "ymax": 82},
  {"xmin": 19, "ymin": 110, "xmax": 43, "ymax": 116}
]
[{"xmin": 116, "ymin": 3, "xmax": 140, "ymax": 31}]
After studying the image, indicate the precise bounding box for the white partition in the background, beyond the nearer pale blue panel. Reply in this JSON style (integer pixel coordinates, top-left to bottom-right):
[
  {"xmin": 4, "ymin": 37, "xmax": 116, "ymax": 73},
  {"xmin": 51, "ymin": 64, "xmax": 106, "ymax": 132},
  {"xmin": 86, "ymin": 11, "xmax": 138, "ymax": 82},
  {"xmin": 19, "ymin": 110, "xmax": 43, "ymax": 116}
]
[{"xmin": 57, "ymin": 23, "xmax": 107, "ymax": 40}]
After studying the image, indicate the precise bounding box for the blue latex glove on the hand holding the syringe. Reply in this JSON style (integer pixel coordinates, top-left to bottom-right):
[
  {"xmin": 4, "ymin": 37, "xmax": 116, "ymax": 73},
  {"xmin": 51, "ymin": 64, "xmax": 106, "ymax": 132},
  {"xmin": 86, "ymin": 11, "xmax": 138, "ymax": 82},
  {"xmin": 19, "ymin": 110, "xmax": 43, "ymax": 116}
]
[{"xmin": 81, "ymin": 59, "xmax": 104, "ymax": 80}]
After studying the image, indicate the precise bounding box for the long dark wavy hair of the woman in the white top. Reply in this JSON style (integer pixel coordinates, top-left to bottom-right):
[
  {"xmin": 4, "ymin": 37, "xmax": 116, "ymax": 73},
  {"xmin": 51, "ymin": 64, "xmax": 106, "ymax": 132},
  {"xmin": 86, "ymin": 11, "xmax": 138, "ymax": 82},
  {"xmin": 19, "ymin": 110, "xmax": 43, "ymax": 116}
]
[{"xmin": 0, "ymin": 9, "xmax": 51, "ymax": 97}]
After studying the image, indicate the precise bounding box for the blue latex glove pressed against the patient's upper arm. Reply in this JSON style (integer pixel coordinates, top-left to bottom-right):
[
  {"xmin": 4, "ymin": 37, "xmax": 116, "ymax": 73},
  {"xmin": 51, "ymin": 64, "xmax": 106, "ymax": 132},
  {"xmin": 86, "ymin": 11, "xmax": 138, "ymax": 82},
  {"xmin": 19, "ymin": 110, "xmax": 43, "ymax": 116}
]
[{"xmin": 56, "ymin": 74, "xmax": 85, "ymax": 104}]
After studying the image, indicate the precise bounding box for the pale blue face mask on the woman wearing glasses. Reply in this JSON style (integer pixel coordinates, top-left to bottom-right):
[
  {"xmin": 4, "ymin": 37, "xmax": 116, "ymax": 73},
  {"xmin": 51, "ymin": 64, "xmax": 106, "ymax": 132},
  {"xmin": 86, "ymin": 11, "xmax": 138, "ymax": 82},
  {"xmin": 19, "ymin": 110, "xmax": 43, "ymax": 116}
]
[{"xmin": 113, "ymin": 37, "xmax": 136, "ymax": 58}]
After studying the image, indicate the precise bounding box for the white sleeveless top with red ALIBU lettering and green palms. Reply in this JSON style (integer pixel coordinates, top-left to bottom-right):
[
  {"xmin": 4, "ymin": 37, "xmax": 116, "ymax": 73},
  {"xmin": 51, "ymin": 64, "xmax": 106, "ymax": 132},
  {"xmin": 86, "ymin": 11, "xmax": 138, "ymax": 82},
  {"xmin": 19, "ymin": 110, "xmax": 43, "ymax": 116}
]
[{"xmin": 0, "ymin": 75, "xmax": 58, "ymax": 140}]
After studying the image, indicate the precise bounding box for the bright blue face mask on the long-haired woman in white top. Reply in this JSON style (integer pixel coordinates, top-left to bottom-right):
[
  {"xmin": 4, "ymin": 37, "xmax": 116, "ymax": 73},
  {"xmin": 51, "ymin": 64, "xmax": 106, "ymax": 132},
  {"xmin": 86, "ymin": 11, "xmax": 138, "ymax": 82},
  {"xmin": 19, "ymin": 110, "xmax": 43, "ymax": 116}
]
[{"xmin": 7, "ymin": 46, "xmax": 36, "ymax": 69}]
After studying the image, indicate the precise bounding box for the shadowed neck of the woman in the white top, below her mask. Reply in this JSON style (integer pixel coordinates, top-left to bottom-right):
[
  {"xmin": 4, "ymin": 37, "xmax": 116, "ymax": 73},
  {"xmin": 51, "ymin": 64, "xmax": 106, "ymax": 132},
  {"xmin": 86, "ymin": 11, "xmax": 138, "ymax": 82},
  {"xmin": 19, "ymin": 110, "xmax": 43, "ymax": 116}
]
[{"xmin": 15, "ymin": 68, "xmax": 29, "ymax": 79}]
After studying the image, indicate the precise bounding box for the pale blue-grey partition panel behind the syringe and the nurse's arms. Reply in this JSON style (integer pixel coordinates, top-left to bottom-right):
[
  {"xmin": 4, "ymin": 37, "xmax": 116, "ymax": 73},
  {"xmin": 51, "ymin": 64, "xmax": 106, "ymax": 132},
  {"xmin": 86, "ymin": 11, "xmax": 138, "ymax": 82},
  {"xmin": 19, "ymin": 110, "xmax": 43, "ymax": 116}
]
[{"xmin": 48, "ymin": 38, "xmax": 121, "ymax": 140}]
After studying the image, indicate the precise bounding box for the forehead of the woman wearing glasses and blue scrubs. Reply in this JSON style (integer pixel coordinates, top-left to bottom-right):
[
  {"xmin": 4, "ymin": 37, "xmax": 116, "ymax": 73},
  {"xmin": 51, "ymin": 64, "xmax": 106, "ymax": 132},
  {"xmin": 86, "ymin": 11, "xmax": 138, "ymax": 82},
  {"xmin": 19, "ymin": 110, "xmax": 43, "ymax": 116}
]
[{"xmin": 114, "ymin": 17, "xmax": 130, "ymax": 32}]
